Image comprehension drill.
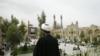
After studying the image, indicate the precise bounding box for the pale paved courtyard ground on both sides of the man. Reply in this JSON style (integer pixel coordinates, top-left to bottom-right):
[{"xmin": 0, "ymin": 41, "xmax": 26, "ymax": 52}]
[{"xmin": 5, "ymin": 39, "xmax": 100, "ymax": 56}]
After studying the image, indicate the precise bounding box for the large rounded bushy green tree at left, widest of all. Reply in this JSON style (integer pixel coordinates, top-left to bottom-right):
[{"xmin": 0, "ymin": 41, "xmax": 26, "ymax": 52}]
[{"xmin": 6, "ymin": 24, "xmax": 22, "ymax": 48}]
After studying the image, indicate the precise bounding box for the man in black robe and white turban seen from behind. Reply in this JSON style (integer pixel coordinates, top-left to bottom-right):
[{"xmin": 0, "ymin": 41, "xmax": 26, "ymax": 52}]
[{"xmin": 33, "ymin": 23, "xmax": 60, "ymax": 56}]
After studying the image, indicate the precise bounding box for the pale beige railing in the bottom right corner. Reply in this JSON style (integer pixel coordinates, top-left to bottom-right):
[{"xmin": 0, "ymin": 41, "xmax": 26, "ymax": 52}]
[{"xmin": 61, "ymin": 47, "xmax": 100, "ymax": 56}]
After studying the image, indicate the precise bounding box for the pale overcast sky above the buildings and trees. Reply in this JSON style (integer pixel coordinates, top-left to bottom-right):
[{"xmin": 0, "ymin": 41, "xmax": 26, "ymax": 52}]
[{"xmin": 0, "ymin": 0, "xmax": 100, "ymax": 28}]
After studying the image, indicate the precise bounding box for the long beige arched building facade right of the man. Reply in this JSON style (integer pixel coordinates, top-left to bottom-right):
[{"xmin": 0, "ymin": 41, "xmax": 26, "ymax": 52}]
[{"xmin": 52, "ymin": 21, "xmax": 100, "ymax": 42}]
